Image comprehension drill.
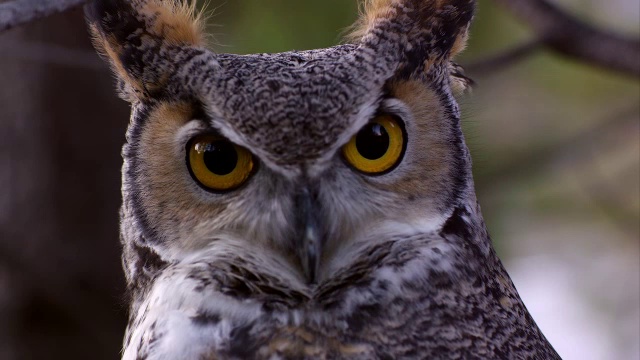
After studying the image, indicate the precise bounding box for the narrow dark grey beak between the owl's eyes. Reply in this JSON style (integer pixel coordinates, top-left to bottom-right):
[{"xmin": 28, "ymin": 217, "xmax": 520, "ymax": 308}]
[{"xmin": 294, "ymin": 185, "xmax": 324, "ymax": 284}]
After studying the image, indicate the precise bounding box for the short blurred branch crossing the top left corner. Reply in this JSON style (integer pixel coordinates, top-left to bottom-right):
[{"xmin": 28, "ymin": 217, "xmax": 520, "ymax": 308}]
[{"xmin": 0, "ymin": 0, "xmax": 88, "ymax": 32}]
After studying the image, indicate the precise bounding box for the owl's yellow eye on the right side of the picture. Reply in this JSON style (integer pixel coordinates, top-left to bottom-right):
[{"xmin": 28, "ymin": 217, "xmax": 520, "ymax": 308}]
[{"xmin": 342, "ymin": 115, "xmax": 405, "ymax": 175}]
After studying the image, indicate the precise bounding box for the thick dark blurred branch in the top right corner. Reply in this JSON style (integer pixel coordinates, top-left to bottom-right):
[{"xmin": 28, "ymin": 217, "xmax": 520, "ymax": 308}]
[{"xmin": 495, "ymin": 0, "xmax": 640, "ymax": 77}]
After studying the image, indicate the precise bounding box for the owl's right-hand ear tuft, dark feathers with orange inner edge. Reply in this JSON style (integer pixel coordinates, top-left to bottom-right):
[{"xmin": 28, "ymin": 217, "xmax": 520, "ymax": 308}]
[{"xmin": 348, "ymin": 0, "xmax": 475, "ymax": 81}]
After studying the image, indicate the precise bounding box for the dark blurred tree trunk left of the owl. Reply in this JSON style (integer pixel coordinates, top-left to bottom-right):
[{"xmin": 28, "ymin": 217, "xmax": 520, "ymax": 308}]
[{"xmin": 0, "ymin": 5, "xmax": 128, "ymax": 359}]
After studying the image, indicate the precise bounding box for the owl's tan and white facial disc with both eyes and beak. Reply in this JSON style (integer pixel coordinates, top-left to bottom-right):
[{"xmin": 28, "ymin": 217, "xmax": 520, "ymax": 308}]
[{"xmin": 126, "ymin": 81, "xmax": 464, "ymax": 282}]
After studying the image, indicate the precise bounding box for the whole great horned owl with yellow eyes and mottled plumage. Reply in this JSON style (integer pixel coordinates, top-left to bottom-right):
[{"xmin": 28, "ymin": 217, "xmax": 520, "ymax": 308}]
[{"xmin": 86, "ymin": 0, "xmax": 558, "ymax": 359}]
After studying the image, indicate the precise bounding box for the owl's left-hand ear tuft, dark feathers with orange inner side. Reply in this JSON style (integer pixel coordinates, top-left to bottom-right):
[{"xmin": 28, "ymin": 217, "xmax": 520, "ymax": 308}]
[{"xmin": 85, "ymin": 0, "xmax": 206, "ymax": 101}]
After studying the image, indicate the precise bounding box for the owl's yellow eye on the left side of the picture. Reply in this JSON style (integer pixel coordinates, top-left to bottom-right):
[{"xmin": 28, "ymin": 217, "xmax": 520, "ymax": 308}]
[{"xmin": 187, "ymin": 135, "xmax": 253, "ymax": 191}]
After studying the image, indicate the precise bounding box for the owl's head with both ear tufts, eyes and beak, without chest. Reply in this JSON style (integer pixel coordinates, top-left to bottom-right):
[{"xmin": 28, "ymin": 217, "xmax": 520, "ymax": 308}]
[{"xmin": 87, "ymin": 0, "xmax": 475, "ymax": 287}]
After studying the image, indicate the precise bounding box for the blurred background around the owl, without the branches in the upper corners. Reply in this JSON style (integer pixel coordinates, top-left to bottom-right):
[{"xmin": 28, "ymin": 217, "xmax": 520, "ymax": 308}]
[{"xmin": 0, "ymin": 0, "xmax": 640, "ymax": 360}]
